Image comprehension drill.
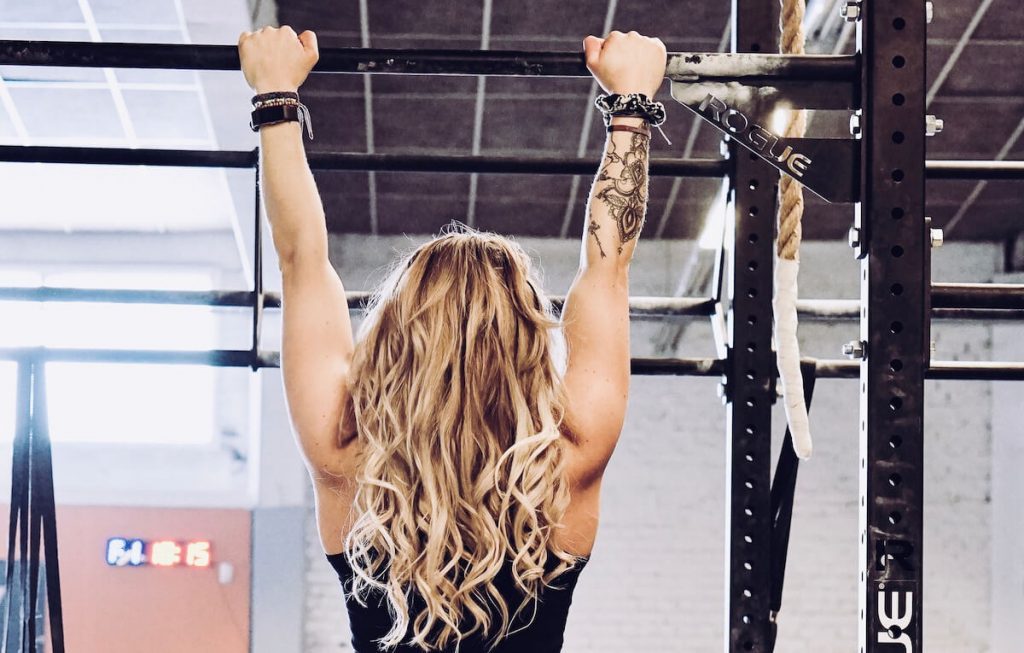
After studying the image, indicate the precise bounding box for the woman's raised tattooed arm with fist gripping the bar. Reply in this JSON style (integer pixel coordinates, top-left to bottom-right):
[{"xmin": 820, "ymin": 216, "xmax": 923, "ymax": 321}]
[{"xmin": 562, "ymin": 32, "xmax": 666, "ymax": 487}]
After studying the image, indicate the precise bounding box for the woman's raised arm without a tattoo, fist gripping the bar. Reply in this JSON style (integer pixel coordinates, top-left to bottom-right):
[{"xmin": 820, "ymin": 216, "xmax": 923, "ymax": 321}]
[{"xmin": 239, "ymin": 27, "xmax": 353, "ymax": 482}]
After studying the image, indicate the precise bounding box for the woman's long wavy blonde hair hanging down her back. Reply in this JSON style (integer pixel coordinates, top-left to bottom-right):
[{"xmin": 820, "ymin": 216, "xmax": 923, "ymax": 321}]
[{"xmin": 345, "ymin": 225, "xmax": 578, "ymax": 651}]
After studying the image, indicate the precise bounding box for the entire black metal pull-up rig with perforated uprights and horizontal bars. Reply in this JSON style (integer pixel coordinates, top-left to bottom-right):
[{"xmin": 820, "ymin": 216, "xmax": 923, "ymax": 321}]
[{"xmin": 0, "ymin": 19, "xmax": 1024, "ymax": 653}]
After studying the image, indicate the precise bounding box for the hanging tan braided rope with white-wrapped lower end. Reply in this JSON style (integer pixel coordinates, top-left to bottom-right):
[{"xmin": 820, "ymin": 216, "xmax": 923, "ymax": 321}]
[{"xmin": 772, "ymin": 0, "xmax": 812, "ymax": 460}]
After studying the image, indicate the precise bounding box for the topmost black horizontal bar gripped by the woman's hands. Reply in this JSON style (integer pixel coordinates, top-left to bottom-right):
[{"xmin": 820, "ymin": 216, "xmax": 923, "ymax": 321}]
[{"xmin": 0, "ymin": 40, "xmax": 859, "ymax": 82}]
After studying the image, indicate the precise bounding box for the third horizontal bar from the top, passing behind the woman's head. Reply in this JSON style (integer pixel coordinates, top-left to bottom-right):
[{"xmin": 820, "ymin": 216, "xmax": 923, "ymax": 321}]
[{"xmin": 8, "ymin": 290, "xmax": 1024, "ymax": 321}]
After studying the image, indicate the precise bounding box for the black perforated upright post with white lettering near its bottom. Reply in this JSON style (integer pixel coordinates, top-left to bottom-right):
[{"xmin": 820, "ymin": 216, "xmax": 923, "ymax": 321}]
[{"xmin": 858, "ymin": 0, "xmax": 931, "ymax": 653}]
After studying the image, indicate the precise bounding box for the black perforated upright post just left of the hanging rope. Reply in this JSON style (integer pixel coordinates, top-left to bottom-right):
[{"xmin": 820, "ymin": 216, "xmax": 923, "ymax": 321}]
[{"xmin": 724, "ymin": 0, "xmax": 778, "ymax": 651}]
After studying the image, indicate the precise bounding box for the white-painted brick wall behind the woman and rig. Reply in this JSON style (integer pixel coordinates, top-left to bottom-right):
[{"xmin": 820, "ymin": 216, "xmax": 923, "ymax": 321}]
[{"xmin": 303, "ymin": 238, "xmax": 997, "ymax": 653}]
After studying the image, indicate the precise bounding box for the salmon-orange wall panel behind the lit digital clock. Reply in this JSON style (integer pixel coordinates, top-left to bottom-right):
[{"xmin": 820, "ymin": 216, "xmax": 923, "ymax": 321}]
[{"xmin": 0, "ymin": 506, "xmax": 252, "ymax": 653}]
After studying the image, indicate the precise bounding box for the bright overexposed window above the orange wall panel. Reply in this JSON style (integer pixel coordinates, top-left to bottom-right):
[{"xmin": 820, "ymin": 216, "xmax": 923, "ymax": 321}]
[{"xmin": 0, "ymin": 270, "xmax": 218, "ymax": 444}]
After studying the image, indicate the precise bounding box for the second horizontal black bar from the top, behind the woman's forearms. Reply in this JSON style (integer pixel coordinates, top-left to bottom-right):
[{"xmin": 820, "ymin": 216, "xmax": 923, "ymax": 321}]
[{"xmin": 0, "ymin": 145, "xmax": 729, "ymax": 178}]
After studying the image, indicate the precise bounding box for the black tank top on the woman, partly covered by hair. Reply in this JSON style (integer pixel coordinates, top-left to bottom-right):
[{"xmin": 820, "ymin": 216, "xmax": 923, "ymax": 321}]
[{"xmin": 327, "ymin": 554, "xmax": 588, "ymax": 653}]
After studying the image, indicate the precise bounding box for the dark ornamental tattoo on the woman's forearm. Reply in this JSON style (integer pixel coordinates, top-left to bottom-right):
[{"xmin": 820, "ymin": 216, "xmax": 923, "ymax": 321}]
[{"xmin": 587, "ymin": 134, "xmax": 648, "ymax": 258}]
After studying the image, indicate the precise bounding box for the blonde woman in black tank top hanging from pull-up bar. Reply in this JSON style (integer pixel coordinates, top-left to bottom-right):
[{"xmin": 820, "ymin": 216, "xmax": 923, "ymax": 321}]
[{"xmin": 239, "ymin": 27, "xmax": 666, "ymax": 653}]
